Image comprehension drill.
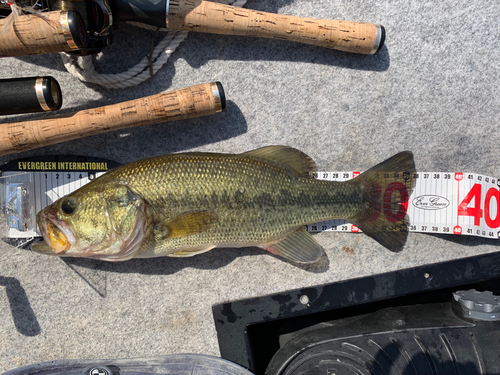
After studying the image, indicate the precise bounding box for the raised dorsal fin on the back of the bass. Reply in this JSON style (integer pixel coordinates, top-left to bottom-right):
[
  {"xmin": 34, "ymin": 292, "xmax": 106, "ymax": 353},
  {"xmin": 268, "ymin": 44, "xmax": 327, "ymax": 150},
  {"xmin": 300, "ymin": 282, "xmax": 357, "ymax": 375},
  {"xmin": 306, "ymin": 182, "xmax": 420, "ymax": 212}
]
[{"xmin": 241, "ymin": 146, "xmax": 316, "ymax": 176}]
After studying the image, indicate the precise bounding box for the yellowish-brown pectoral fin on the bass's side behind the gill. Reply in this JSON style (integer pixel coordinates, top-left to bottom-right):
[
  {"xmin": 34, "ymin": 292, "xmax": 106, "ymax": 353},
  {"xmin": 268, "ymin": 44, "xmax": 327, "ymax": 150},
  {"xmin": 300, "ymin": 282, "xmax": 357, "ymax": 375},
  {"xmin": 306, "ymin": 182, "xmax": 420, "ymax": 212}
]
[{"xmin": 155, "ymin": 210, "xmax": 218, "ymax": 238}]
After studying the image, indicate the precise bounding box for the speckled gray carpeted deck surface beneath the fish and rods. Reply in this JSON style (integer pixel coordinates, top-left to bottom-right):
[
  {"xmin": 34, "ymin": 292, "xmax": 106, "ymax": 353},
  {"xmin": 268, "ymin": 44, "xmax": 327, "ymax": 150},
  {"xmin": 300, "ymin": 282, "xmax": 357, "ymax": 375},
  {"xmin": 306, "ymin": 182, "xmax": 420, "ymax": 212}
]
[{"xmin": 0, "ymin": 0, "xmax": 500, "ymax": 372}]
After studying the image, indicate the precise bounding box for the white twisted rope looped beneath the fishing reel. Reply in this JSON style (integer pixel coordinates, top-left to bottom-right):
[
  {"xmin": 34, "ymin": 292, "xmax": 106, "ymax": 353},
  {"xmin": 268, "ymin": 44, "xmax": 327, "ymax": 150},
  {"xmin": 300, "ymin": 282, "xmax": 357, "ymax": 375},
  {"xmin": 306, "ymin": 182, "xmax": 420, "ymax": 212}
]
[{"xmin": 61, "ymin": 0, "xmax": 247, "ymax": 89}]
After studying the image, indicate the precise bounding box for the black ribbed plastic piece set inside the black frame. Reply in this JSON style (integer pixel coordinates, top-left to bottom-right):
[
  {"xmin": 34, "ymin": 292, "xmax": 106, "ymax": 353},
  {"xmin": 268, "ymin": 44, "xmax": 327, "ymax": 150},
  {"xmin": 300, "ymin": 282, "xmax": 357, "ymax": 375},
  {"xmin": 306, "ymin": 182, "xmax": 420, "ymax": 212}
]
[{"xmin": 266, "ymin": 302, "xmax": 500, "ymax": 375}]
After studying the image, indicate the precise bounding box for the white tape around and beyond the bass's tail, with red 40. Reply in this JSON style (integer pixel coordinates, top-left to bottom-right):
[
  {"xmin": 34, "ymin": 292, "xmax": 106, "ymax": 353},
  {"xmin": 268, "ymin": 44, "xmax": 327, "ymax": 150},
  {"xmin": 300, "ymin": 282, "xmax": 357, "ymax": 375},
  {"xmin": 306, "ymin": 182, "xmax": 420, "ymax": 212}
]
[{"xmin": 306, "ymin": 172, "xmax": 500, "ymax": 239}]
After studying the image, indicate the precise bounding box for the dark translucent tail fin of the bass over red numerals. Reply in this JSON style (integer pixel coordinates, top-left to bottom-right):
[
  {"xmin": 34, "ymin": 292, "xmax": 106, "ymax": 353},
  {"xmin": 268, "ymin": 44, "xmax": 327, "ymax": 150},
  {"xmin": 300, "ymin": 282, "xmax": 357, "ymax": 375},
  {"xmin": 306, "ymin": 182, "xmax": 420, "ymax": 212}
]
[{"xmin": 353, "ymin": 151, "xmax": 415, "ymax": 252}]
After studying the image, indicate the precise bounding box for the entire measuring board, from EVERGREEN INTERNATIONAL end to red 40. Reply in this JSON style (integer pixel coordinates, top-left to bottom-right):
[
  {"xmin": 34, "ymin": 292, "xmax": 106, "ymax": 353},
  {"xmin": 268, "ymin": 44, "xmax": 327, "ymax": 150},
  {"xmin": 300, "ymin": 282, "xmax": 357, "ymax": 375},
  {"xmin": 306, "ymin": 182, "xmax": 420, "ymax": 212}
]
[{"xmin": 0, "ymin": 156, "xmax": 500, "ymax": 239}]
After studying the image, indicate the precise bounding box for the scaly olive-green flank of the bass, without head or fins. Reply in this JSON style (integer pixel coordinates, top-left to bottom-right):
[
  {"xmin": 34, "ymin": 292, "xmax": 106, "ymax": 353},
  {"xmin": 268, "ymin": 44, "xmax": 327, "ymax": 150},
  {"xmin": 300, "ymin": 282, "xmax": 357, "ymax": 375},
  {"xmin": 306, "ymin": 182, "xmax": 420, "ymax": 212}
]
[{"xmin": 89, "ymin": 155, "xmax": 362, "ymax": 255}]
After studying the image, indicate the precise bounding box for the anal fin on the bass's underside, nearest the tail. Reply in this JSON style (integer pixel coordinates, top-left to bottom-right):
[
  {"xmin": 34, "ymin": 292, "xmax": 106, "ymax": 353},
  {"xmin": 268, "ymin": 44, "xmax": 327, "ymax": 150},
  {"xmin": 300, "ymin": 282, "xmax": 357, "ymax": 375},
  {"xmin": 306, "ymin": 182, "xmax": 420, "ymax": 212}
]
[{"xmin": 263, "ymin": 228, "xmax": 323, "ymax": 263}]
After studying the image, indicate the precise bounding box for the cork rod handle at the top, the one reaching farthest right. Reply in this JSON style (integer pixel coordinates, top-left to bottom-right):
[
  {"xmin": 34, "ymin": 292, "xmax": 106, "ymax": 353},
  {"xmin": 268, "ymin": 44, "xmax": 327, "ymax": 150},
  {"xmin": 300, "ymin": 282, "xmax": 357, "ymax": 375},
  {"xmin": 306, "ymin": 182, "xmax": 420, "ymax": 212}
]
[{"xmin": 168, "ymin": 0, "xmax": 385, "ymax": 54}]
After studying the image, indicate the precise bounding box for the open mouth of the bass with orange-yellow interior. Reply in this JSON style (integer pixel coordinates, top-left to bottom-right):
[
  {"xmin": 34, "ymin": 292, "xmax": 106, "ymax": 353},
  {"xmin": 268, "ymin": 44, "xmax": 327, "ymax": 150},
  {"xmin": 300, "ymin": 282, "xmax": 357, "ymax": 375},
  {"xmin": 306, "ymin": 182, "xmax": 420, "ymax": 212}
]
[{"xmin": 32, "ymin": 214, "xmax": 75, "ymax": 255}]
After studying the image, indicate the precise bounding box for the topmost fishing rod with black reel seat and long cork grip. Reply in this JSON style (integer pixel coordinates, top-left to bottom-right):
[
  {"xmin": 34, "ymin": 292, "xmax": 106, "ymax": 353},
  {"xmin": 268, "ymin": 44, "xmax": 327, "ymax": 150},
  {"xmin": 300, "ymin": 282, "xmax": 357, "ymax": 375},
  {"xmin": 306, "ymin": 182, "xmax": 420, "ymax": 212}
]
[{"xmin": 0, "ymin": 0, "xmax": 385, "ymax": 54}]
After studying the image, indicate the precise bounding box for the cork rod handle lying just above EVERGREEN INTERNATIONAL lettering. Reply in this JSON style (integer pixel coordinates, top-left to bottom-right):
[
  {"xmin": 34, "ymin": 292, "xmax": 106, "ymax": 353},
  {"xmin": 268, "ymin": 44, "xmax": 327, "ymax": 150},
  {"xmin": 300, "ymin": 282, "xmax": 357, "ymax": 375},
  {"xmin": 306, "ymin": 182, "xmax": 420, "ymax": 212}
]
[{"xmin": 0, "ymin": 82, "xmax": 225, "ymax": 156}]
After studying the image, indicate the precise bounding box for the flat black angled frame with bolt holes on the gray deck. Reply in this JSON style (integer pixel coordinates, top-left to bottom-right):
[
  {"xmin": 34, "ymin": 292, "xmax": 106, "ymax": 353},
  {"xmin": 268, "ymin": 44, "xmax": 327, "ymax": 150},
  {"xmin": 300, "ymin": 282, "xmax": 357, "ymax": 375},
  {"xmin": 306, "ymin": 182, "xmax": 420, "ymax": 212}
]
[{"xmin": 212, "ymin": 253, "xmax": 500, "ymax": 375}]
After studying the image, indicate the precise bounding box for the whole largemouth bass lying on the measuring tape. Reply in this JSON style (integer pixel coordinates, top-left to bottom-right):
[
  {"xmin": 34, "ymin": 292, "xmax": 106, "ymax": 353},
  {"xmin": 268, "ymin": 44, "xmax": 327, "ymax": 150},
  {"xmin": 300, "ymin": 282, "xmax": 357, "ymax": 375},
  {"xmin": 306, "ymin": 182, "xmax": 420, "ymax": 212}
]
[{"xmin": 33, "ymin": 146, "xmax": 415, "ymax": 263}]
